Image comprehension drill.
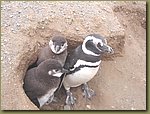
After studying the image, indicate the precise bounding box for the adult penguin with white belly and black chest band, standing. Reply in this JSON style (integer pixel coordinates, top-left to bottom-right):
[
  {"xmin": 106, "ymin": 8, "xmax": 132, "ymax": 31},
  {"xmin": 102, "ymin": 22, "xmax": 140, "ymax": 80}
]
[{"xmin": 63, "ymin": 34, "xmax": 113, "ymax": 104}]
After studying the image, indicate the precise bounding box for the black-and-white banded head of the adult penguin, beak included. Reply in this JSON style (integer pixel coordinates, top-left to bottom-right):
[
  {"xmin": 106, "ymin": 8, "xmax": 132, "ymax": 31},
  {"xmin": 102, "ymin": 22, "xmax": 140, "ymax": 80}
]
[{"xmin": 82, "ymin": 34, "xmax": 114, "ymax": 56}]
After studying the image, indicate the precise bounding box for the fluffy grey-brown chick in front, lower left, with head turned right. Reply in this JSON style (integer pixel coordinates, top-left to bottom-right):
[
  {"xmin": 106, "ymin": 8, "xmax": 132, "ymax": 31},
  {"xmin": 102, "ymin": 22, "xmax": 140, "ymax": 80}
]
[{"xmin": 23, "ymin": 59, "xmax": 66, "ymax": 107}]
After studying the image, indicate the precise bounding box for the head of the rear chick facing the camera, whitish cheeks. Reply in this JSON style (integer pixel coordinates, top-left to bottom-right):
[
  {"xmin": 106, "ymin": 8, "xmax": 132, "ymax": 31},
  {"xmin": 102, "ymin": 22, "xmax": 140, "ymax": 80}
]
[{"xmin": 49, "ymin": 36, "xmax": 68, "ymax": 54}]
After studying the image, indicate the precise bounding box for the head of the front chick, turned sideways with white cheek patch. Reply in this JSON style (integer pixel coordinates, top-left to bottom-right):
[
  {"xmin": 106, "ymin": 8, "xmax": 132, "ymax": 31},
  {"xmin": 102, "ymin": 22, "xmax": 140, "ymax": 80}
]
[{"xmin": 38, "ymin": 59, "xmax": 67, "ymax": 77}]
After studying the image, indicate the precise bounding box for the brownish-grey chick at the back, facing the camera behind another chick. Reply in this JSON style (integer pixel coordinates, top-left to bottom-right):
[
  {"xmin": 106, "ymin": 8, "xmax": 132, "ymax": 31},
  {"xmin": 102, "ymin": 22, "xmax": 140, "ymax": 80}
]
[{"xmin": 36, "ymin": 36, "xmax": 68, "ymax": 66}]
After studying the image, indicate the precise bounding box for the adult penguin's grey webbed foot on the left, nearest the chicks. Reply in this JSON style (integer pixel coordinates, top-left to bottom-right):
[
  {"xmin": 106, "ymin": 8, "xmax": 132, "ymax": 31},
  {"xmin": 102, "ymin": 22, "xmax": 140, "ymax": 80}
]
[{"xmin": 66, "ymin": 90, "xmax": 76, "ymax": 105}]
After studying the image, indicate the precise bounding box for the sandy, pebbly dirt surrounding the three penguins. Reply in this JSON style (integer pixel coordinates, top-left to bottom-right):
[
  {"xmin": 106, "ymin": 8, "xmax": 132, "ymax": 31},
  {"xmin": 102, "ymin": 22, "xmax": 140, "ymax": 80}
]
[{"xmin": 1, "ymin": 2, "xmax": 146, "ymax": 110}]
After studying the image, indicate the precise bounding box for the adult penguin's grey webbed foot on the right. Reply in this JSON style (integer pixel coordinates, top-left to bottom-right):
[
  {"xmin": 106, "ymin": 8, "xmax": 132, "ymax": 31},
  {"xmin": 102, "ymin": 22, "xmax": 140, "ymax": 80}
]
[{"xmin": 82, "ymin": 83, "xmax": 96, "ymax": 99}]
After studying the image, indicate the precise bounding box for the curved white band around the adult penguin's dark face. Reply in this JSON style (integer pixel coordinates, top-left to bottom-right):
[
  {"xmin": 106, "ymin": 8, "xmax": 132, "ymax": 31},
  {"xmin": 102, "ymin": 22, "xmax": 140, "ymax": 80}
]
[{"xmin": 82, "ymin": 36, "xmax": 104, "ymax": 56}]
